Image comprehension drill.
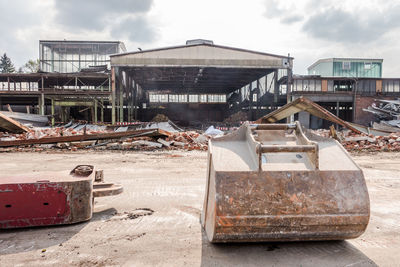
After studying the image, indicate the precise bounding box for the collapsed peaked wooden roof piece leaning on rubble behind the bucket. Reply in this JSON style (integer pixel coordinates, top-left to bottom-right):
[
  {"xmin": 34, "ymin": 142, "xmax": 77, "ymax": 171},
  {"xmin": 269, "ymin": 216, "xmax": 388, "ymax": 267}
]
[{"xmin": 256, "ymin": 97, "xmax": 361, "ymax": 134}]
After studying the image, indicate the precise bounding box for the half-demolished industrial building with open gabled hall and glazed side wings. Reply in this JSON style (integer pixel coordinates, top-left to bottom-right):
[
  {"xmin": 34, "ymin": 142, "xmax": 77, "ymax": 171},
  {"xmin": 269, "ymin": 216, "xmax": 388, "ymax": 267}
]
[{"xmin": 0, "ymin": 39, "xmax": 400, "ymax": 129}]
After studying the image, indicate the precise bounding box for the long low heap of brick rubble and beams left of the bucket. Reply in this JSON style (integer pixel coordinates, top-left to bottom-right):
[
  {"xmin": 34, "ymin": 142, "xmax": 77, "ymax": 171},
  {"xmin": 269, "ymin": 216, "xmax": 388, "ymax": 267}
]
[{"xmin": 0, "ymin": 122, "xmax": 209, "ymax": 151}]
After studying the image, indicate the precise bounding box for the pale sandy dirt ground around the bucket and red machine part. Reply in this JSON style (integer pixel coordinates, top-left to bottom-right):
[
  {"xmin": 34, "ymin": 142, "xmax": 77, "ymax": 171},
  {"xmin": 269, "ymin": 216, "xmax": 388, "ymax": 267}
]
[{"xmin": 0, "ymin": 151, "xmax": 400, "ymax": 266}]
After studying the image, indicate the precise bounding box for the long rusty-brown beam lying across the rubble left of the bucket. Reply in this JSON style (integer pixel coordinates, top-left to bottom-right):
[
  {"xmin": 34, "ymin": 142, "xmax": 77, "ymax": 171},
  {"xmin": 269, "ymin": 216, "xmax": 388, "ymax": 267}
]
[{"xmin": 0, "ymin": 129, "xmax": 171, "ymax": 147}]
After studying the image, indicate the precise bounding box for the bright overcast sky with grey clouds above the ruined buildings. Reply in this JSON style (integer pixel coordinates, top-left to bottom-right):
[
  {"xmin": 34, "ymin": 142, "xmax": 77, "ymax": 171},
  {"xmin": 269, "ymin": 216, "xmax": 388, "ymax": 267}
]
[{"xmin": 0, "ymin": 0, "xmax": 400, "ymax": 77}]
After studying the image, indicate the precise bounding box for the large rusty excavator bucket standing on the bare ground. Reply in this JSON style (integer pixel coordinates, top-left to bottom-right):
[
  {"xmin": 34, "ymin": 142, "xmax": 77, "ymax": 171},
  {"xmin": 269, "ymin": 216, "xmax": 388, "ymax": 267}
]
[{"xmin": 201, "ymin": 122, "xmax": 370, "ymax": 242}]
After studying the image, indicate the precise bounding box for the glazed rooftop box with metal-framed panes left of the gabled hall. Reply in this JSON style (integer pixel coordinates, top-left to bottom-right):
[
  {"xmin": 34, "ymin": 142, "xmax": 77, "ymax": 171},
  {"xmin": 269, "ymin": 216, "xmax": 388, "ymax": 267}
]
[{"xmin": 39, "ymin": 41, "xmax": 126, "ymax": 73}]
